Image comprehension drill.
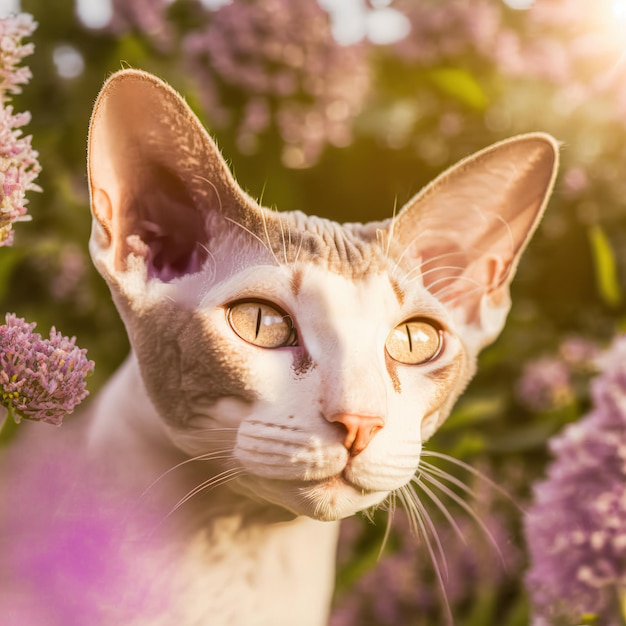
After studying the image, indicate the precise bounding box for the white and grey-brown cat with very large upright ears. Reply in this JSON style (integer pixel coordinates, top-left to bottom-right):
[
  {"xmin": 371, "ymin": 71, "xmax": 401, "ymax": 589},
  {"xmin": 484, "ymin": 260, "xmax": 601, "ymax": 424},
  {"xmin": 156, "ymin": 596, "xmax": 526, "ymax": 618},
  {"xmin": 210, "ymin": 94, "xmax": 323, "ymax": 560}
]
[{"xmin": 0, "ymin": 70, "xmax": 558, "ymax": 626}]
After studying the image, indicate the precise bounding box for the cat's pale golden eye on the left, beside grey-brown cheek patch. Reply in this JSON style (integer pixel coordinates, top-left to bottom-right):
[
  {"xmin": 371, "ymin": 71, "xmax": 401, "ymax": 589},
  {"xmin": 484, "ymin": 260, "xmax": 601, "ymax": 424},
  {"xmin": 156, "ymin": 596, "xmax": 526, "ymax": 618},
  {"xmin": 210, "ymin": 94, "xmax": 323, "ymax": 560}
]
[{"xmin": 226, "ymin": 300, "xmax": 298, "ymax": 348}]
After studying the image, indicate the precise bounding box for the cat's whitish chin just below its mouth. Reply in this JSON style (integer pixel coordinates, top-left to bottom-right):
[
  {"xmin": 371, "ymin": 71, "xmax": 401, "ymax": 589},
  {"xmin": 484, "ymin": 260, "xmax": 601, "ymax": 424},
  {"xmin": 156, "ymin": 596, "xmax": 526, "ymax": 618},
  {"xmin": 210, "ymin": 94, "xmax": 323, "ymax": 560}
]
[{"xmin": 232, "ymin": 475, "xmax": 389, "ymax": 522}]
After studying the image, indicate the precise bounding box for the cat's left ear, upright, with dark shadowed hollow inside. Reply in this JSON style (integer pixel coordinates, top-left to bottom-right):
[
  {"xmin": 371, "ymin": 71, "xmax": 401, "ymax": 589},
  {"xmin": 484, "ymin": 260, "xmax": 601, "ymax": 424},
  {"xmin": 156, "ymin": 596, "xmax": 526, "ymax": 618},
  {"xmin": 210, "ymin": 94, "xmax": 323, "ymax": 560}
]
[{"xmin": 88, "ymin": 70, "xmax": 259, "ymax": 283}]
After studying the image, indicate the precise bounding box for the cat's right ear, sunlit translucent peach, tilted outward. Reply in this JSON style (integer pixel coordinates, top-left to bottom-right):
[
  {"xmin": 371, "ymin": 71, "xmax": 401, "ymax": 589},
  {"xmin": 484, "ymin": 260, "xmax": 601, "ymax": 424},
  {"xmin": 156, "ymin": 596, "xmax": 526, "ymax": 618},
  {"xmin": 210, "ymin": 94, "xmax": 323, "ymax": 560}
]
[{"xmin": 390, "ymin": 133, "xmax": 558, "ymax": 349}]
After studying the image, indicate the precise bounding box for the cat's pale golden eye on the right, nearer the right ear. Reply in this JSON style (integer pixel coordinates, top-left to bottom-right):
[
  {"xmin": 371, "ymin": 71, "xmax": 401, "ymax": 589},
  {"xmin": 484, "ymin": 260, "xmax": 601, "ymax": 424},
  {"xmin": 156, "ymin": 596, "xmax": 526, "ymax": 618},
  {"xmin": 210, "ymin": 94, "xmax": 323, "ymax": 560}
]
[{"xmin": 385, "ymin": 319, "xmax": 443, "ymax": 365}]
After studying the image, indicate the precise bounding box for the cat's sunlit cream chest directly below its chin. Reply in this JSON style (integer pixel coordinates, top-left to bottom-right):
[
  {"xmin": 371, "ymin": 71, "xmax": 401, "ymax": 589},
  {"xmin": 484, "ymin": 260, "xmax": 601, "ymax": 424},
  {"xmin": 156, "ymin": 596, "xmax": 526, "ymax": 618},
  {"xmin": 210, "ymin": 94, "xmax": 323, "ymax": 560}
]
[{"xmin": 161, "ymin": 518, "xmax": 338, "ymax": 626}]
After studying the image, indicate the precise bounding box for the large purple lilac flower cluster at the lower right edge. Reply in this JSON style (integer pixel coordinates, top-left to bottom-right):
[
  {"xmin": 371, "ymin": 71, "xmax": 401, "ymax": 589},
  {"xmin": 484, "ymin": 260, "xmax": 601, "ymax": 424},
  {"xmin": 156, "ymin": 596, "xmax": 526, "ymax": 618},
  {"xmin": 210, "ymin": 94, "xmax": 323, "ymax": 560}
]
[{"xmin": 525, "ymin": 336, "xmax": 626, "ymax": 626}]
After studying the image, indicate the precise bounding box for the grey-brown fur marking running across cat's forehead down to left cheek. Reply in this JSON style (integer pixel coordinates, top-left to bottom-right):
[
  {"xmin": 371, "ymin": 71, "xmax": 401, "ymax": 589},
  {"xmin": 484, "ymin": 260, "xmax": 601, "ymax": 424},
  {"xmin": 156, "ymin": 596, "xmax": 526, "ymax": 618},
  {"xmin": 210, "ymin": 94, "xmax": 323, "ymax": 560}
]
[{"xmin": 125, "ymin": 211, "xmax": 412, "ymax": 425}]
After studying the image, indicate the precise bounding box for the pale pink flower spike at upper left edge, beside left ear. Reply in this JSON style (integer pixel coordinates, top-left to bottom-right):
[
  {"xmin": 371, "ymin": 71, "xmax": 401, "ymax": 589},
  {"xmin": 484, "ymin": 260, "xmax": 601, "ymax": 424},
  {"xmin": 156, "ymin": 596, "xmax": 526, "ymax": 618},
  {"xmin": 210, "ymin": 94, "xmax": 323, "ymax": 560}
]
[{"xmin": 0, "ymin": 14, "xmax": 41, "ymax": 246}]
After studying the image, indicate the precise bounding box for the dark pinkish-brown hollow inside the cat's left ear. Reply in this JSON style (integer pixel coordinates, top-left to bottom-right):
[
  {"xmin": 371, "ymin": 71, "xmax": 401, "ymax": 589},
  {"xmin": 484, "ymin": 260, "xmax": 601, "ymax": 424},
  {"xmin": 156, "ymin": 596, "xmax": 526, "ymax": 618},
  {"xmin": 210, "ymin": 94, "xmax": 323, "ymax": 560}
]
[{"xmin": 114, "ymin": 164, "xmax": 210, "ymax": 281}]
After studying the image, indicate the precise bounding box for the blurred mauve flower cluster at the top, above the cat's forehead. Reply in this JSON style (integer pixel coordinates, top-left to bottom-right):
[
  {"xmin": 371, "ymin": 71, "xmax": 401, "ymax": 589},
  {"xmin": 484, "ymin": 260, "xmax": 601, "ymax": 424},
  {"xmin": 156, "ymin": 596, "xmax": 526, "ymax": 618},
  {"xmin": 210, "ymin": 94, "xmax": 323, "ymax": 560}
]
[{"xmin": 185, "ymin": 0, "xmax": 369, "ymax": 167}]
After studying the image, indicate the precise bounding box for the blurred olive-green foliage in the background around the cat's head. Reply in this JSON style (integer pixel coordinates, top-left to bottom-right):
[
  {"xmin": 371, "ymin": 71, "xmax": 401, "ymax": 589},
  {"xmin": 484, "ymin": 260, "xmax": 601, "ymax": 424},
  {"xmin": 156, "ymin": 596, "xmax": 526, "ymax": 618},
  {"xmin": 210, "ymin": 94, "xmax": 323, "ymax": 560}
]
[{"xmin": 0, "ymin": 0, "xmax": 626, "ymax": 626}]
